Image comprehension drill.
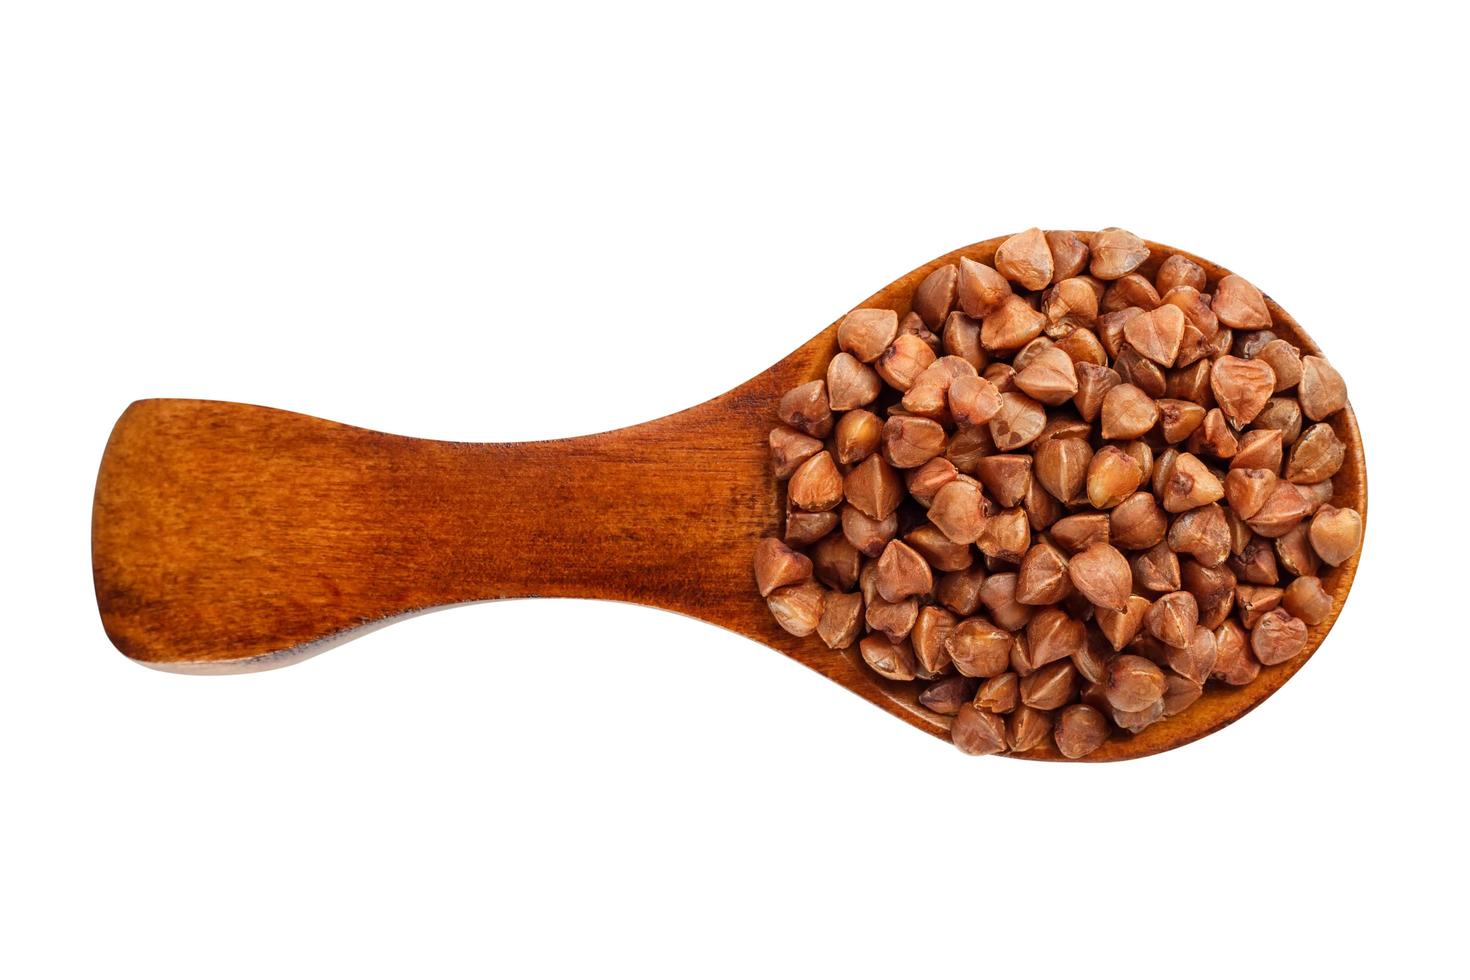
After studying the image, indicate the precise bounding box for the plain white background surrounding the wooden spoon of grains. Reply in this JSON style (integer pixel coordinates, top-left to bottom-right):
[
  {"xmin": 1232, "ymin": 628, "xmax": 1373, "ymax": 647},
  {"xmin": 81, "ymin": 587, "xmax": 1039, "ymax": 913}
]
[{"xmin": 0, "ymin": 1, "xmax": 1470, "ymax": 977}]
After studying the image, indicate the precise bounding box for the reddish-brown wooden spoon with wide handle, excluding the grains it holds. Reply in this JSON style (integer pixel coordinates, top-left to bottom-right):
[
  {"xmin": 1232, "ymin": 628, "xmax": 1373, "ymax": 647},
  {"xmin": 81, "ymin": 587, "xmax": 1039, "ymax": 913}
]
[{"xmin": 93, "ymin": 238, "xmax": 1367, "ymax": 761}]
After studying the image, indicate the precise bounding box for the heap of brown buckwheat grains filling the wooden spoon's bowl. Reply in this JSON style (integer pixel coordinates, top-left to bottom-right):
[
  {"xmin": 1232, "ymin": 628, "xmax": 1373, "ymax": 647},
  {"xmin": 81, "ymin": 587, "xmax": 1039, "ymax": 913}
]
[{"xmin": 756, "ymin": 228, "xmax": 1363, "ymax": 758}]
